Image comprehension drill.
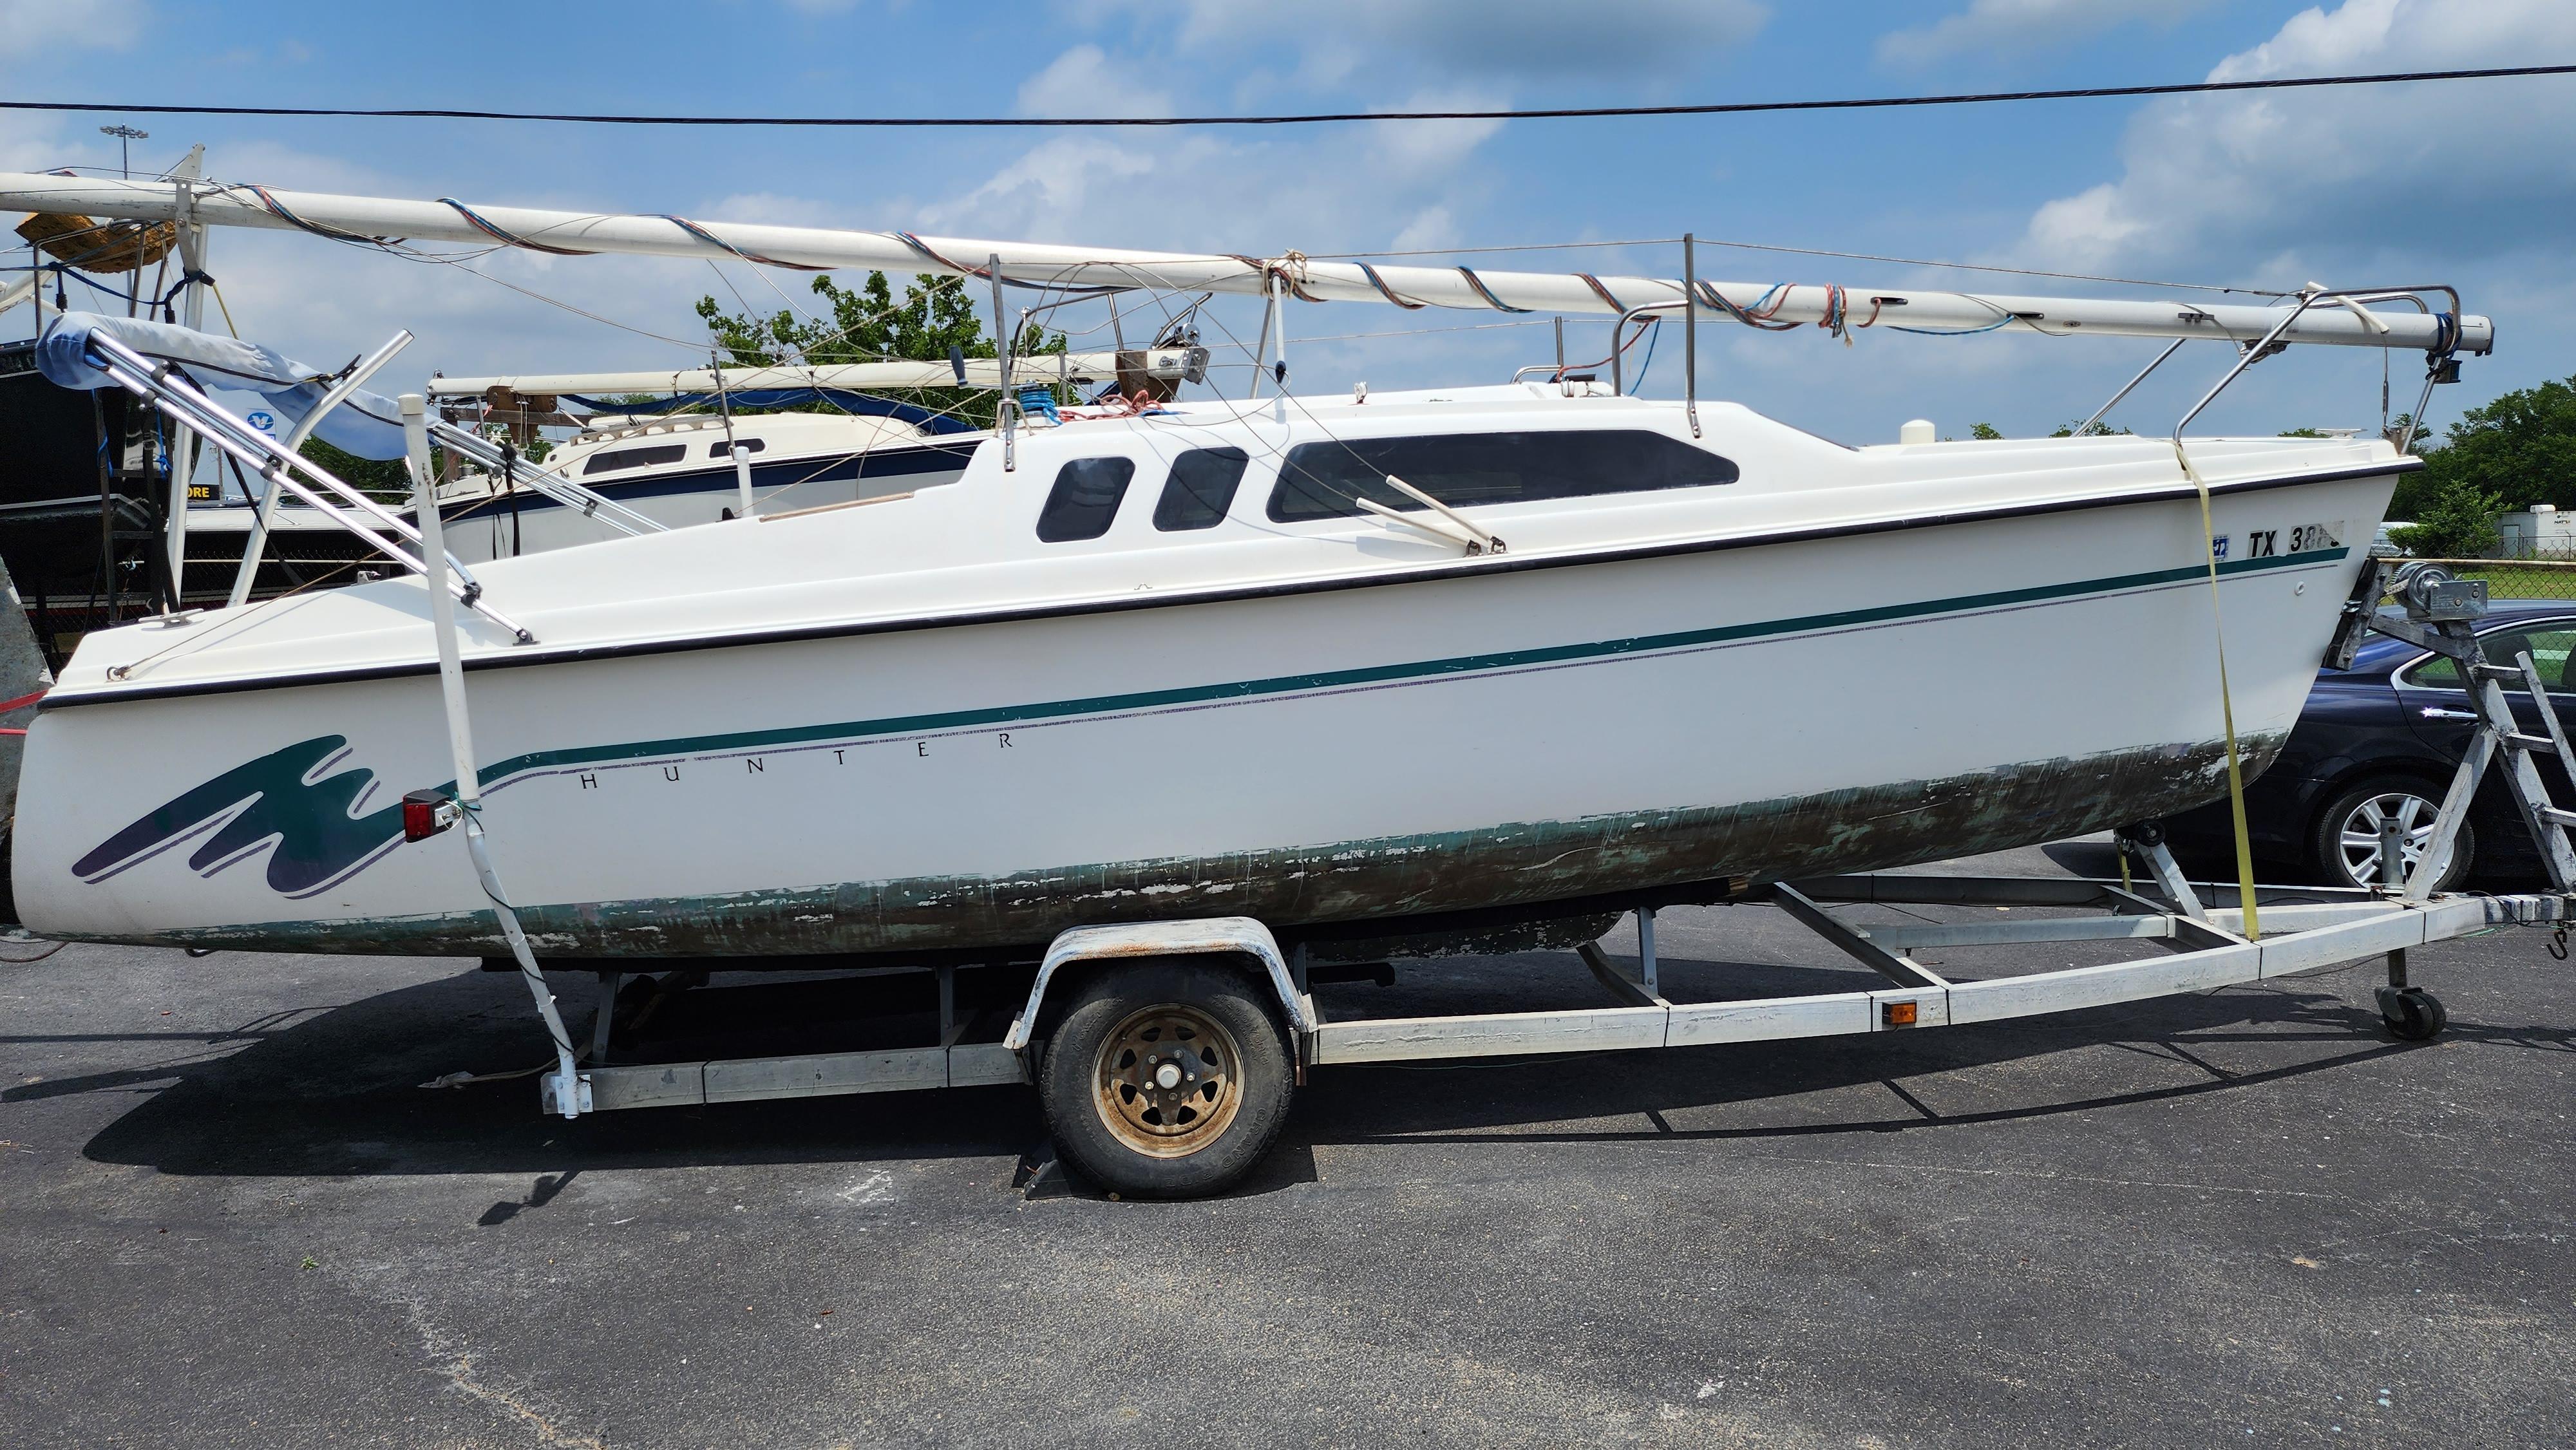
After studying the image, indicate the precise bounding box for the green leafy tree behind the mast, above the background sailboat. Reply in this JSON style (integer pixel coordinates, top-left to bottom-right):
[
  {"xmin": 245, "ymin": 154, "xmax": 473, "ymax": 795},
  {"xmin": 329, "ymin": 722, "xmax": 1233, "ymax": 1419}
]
[{"xmin": 698, "ymin": 273, "xmax": 1069, "ymax": 428}]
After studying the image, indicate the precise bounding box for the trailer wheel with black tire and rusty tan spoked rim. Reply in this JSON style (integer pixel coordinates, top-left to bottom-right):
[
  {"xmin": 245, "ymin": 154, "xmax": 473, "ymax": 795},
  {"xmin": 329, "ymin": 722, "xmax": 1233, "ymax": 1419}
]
[{"xmin": 1038, "ymin": 958, "xmax": 1296, "ymax": 1198}]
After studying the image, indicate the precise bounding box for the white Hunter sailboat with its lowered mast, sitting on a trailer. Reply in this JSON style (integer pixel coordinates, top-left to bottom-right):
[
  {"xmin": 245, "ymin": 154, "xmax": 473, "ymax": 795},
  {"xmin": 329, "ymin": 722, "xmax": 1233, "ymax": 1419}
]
[{"xmin": 0, "ymin": 178, "xmax": 2491, "ymax": 958}]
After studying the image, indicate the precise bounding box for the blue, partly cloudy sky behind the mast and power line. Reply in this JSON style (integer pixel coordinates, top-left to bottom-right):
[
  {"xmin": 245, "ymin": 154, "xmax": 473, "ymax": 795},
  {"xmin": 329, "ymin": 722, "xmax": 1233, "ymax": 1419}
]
[{"xmin": 0, "ymin": 0, "xmax": 2576, "ymax": 443}]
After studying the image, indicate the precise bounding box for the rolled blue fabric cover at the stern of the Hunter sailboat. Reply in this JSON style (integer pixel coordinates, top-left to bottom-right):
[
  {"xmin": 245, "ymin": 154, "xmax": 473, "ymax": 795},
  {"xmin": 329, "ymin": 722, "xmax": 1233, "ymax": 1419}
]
[{"xmin": 36, "ymin": 312, "xmax": 404, "ymax": 461}]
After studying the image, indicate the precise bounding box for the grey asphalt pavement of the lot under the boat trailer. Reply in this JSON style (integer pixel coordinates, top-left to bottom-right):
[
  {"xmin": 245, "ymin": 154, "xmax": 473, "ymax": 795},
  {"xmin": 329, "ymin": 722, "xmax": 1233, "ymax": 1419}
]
[{"xmin": 0, "ymin": 845, "xmax": 2576, "ymax": 1450}]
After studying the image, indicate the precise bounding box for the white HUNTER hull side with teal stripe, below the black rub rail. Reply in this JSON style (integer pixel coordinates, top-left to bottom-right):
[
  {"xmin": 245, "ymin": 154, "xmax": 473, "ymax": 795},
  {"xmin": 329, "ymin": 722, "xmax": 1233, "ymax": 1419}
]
[{"xmin": 15, "ymin": 474, "xmax": 2393, "ymax": 958}]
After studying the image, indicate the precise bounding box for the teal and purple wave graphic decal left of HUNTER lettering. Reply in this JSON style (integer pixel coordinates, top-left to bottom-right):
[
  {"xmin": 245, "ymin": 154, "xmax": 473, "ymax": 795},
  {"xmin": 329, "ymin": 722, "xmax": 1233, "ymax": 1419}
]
[{"xmin": 72, "ymin": 734, "xmax": 402, "ymax": 896}]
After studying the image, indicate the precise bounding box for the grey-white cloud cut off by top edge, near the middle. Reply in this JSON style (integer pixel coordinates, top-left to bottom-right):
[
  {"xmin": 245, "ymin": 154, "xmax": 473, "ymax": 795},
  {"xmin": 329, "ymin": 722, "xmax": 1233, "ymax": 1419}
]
[{"xmin": 1154, "ymin": 0, "xmax": 1770, "ymax": 82}]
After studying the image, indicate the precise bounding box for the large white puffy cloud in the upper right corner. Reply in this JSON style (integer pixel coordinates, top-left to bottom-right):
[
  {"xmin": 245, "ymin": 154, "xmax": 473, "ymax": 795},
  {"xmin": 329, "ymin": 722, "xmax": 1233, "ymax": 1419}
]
[{"xmin": 2022, "ymin": 0, "xmax": 2576, "ymax": 283}]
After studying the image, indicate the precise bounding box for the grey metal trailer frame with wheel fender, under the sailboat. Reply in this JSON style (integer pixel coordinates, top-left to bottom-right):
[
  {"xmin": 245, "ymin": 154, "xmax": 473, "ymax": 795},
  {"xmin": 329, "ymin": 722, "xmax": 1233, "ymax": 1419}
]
[{"xmin": 554, "ymin": 840, "xmax": 2576, "ymax": 1113}]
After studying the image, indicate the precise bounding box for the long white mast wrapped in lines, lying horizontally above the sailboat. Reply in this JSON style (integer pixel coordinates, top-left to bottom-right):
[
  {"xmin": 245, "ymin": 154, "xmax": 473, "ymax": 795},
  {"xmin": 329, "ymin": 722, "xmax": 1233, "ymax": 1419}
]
[{"xmin": 0, "ymin": 173, "xmax": 2494, "ymax": 353}]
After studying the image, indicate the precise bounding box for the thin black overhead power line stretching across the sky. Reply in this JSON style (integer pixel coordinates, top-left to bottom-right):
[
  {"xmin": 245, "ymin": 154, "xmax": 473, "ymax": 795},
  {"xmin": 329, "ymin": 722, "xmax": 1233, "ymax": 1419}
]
[{"xmin": 0, "ymin": 64, "xmax": 2576, "ymax": 129}]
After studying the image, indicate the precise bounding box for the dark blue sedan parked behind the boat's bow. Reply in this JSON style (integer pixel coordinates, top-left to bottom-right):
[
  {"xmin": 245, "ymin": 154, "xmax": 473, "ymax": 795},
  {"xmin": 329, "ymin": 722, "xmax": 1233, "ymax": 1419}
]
[{"xmin": 2164, "ymin": 600, "xmax": 2576, "ymax": 889}]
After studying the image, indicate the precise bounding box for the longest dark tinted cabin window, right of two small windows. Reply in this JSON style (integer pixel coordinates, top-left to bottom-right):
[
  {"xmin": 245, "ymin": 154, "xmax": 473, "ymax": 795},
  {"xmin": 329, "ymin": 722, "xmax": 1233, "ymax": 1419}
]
[{"xmin": 1270, "ymin": 430, "xmax": 1736, "ymax": 523}]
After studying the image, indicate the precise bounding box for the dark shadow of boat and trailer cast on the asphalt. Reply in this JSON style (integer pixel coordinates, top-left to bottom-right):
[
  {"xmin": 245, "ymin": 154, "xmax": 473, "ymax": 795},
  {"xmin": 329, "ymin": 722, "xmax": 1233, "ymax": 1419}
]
[{"xmin": 15, "ymin": 953, "xmax": 2527, "ymax": 1218}]
